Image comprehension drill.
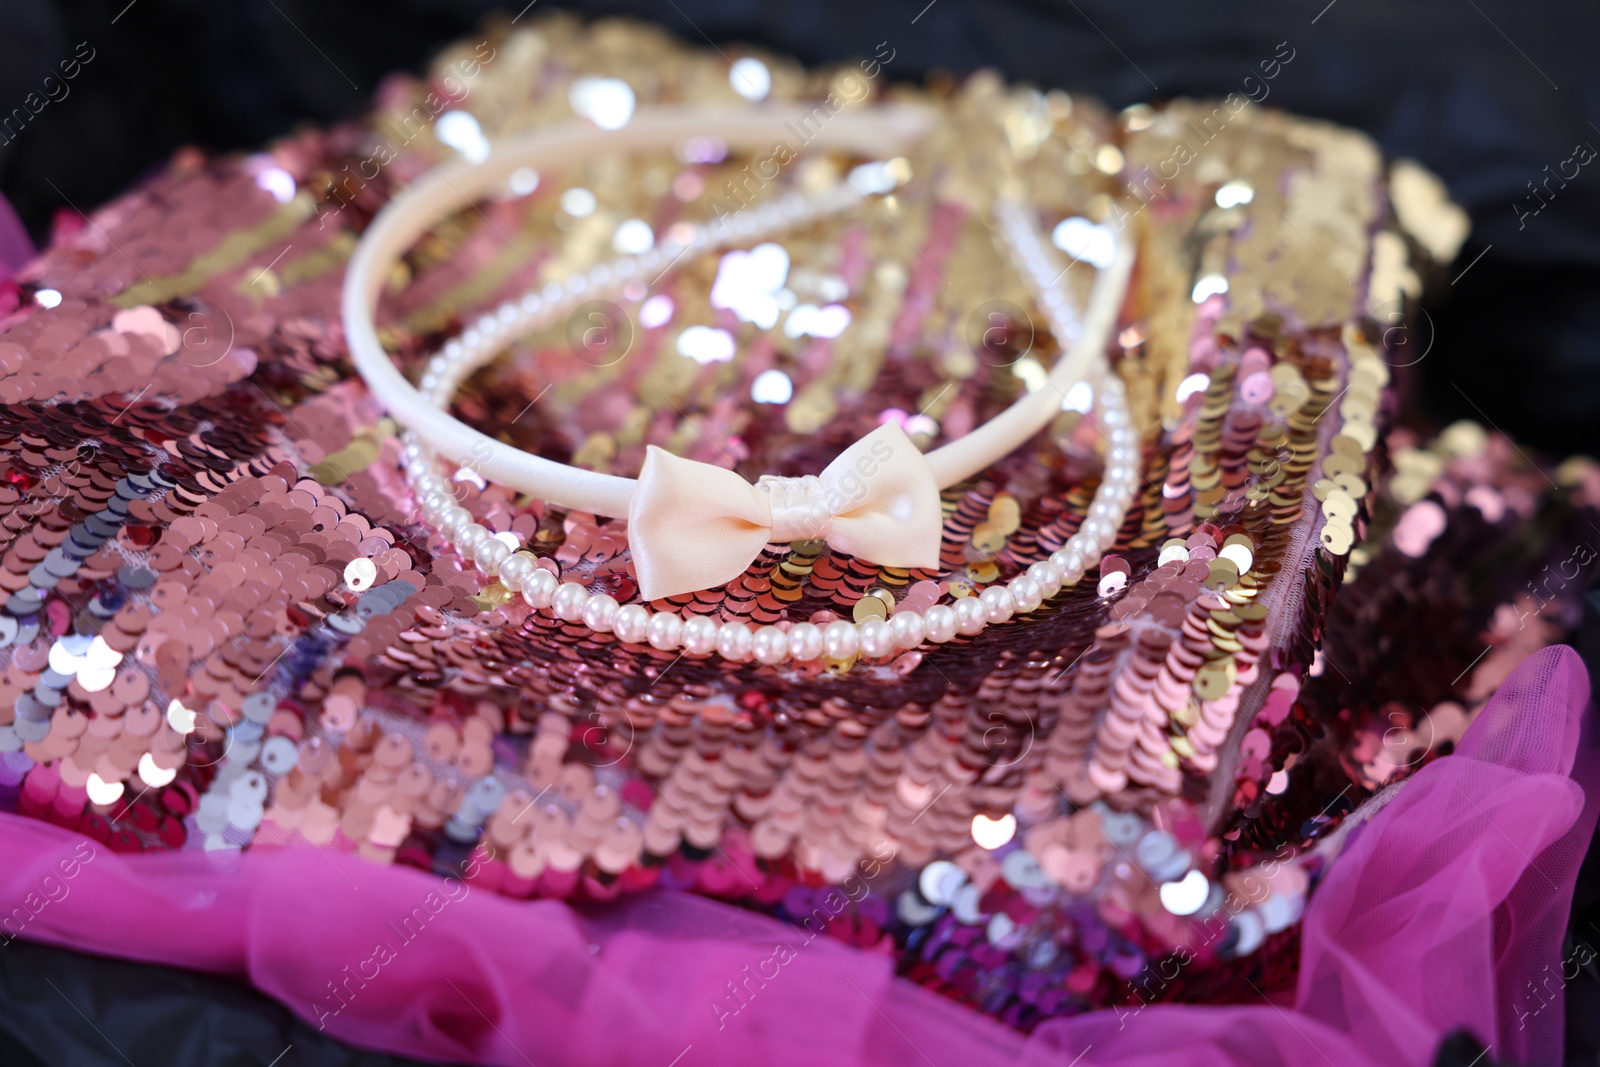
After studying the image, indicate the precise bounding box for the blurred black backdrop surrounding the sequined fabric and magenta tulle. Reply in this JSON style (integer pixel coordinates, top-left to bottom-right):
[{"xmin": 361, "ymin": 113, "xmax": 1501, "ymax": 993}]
[{"xmin": 0, "ymin": 0, "xmax": 1600, "ymax": 1067}]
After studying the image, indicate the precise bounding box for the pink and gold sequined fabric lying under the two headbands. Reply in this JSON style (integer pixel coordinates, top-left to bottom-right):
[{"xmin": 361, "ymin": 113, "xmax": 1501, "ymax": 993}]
[{"xmin": 0, "ymin": 19, "xmax": 1600, "ymax": 1049}]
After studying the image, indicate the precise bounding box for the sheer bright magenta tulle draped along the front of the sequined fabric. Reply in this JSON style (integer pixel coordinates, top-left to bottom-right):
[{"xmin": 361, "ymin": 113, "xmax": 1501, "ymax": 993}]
[{"xmin": 0, "ymin": 648, "xmax": 1597, "ymax": 1067}]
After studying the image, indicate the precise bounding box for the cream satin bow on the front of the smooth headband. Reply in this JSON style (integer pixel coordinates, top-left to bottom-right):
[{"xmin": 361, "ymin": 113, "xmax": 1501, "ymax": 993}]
[{"xmin": 627, "ymin": 422, "xmax": 944, "ymax": 600}]
